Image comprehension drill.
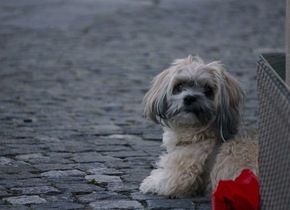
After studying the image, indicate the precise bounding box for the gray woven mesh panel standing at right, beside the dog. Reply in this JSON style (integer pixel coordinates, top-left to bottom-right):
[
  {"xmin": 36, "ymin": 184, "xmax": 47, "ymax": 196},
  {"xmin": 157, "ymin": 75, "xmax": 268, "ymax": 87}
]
[{"xmin": 257, "ymin": 55, "xmax": 290, "ymax": 210}]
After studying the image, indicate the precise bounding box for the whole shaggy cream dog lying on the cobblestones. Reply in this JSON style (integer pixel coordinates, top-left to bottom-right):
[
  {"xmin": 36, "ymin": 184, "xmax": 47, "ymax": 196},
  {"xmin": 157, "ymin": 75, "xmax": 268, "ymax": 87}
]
[{"xmin": 140, "ymin": 56, "xmax": 258, "ymax": 197}]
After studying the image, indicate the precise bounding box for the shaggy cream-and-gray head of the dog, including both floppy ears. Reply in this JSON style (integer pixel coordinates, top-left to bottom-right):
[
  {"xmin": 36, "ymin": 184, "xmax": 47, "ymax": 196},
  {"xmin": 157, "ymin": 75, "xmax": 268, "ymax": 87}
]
[{"xmin": 143, "ymin": 56, "xmax": 244, "ymax": 140}]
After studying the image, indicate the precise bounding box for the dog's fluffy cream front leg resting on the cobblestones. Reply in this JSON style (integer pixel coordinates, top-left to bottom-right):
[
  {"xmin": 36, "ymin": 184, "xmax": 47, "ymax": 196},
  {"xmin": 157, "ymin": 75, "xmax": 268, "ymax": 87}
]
[{"xmin": 140, "ymin": 148, "xmax": 207, "ymax": 197}]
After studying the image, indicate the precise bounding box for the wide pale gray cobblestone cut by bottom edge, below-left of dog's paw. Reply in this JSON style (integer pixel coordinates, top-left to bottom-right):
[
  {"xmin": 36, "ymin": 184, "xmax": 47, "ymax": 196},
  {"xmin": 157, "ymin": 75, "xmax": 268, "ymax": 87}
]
[{"xmin": 90, "ymin": 200, "xmax": 144, "ymax": 209}]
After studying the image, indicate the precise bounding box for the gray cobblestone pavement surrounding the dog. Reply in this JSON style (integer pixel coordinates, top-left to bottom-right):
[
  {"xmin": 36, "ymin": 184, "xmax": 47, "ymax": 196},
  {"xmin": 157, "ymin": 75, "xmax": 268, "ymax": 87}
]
[{"xmin": 0, "ymin": 0, "xmax": 285, "ymax": 210}]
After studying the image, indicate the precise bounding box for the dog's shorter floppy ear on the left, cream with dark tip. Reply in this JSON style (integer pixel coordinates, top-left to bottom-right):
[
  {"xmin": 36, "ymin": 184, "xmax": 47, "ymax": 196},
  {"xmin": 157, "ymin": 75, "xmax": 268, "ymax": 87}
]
[{"xmin": 143, "ymin": 69, "xmax": 170, "ymax": 124}]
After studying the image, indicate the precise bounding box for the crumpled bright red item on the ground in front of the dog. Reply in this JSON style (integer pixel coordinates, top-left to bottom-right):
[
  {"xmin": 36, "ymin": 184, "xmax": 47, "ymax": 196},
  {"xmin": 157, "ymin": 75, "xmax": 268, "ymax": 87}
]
[{"xmin": 212, "ymin": 169, "xmax": 259, "ymax": 210}]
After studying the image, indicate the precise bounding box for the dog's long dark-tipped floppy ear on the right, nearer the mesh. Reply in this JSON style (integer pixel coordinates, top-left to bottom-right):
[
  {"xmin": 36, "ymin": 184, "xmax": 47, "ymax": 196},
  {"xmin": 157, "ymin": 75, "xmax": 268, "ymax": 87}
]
[{"xmin": 216, "ymin": 69, "xmax": 244, "ymax": 141}]
